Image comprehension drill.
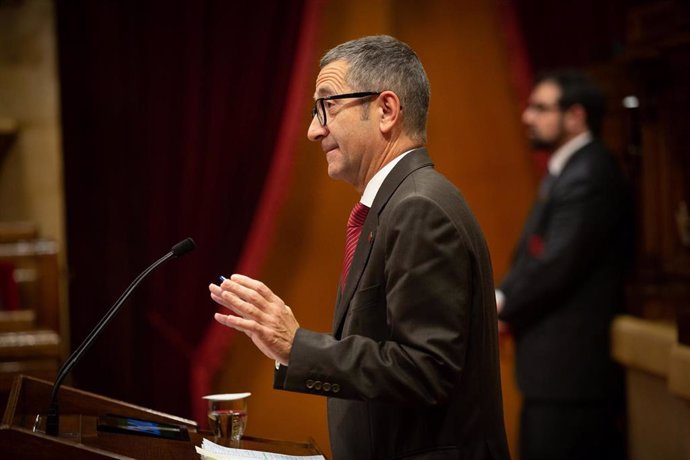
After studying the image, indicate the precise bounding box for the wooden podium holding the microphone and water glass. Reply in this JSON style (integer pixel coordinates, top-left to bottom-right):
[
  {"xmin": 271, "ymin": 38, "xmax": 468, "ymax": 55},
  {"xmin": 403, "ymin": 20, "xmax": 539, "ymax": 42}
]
[{"xmin": 0, "ymin": 375, "xmax": 321, "ymax": 460}]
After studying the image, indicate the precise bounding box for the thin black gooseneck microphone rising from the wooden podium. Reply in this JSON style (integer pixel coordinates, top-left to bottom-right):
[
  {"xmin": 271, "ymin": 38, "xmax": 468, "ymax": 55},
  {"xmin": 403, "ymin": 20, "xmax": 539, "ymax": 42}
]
[{"xmin": 46, "ymin": 238, "xmax": 196, "ymax": 436}]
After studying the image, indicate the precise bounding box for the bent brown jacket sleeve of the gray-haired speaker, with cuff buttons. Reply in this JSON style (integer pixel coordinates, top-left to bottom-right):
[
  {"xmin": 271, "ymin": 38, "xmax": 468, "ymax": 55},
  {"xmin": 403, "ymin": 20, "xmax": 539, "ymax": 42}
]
[{"xmin": 276, "ymin": 196, "xmax": 474, "ymax": 405}]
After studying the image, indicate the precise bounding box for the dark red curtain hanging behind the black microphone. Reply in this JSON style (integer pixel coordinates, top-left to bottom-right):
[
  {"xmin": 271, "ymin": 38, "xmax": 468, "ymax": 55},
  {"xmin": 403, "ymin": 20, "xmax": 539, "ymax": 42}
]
[{"xmin": 57, "ymin": 0, "xmax": 314, "ymax": 417}]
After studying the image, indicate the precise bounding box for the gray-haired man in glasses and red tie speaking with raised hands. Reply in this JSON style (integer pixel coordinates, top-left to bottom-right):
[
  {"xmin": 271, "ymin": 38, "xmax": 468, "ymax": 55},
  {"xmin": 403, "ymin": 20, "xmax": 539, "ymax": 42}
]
[{"xmin": 210, "ymin": 36, "xmax": 508, "ymax": 460}]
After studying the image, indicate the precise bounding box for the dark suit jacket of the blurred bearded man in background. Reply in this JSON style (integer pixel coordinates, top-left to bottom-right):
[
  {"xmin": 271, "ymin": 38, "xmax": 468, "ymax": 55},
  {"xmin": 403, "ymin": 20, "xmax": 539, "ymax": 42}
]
[{"xmin": 499, "ymin": 141, "xmax": 633, "ymax": 400}]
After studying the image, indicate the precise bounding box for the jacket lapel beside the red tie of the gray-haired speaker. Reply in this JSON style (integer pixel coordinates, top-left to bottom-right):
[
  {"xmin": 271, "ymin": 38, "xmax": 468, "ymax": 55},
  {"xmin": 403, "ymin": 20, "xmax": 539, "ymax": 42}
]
[{"xmin": 333, "ymin": 148, "xmax": 433, "ymax": 338}]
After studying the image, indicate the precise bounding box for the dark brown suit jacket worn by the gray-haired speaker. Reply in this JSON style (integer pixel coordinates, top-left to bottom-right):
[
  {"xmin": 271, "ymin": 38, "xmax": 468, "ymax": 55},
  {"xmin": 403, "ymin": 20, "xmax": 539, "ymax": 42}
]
[{"xmin": 276, "ymin": 149, "xmax": 508, "ymax": 460}]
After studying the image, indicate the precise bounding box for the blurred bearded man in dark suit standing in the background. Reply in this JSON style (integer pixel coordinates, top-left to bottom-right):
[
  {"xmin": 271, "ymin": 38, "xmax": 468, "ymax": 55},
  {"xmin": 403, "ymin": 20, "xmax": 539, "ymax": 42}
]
[{"xmin": 497, "ymin": 71, "xmax": 633, "ymax": 460}]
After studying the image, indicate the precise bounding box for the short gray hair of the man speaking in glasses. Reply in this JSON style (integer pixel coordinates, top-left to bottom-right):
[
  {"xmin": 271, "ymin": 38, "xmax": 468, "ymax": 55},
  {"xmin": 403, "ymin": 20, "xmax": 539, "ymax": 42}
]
[{"xmin": 319, "ymin": 35, "xmax": 431, "ymax": 143}]
